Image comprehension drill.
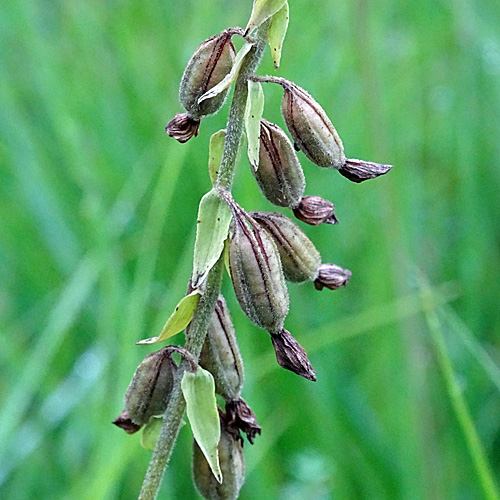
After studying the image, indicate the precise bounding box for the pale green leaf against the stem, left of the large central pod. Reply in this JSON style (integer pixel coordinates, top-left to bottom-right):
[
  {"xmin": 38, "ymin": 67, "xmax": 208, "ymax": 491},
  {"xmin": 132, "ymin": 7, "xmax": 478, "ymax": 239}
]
[{"xmin": 191, "ymin": 189, "xmax": 231, "ymax": 288}]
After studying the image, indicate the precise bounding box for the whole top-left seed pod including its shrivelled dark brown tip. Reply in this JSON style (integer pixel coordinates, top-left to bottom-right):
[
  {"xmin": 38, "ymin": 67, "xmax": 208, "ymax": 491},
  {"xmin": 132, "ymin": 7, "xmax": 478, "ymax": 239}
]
[{"xmin": 165, "ymin": 30, "xmax": 235, "ymax": 142}]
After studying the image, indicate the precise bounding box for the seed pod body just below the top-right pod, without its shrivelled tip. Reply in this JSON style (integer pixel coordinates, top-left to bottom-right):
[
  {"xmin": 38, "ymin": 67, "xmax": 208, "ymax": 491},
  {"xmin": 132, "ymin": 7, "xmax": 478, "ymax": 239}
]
[{"xmin": 251, "ymin": 120, "xmax": 306, "ymax": 207}]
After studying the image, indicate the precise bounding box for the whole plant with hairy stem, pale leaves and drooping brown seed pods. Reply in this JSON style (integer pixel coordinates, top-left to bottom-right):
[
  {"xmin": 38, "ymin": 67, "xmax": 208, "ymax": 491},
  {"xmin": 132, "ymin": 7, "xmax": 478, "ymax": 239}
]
[{"xmin": 114, "ymin": 0, "xmax": 391, "ymax": 500}]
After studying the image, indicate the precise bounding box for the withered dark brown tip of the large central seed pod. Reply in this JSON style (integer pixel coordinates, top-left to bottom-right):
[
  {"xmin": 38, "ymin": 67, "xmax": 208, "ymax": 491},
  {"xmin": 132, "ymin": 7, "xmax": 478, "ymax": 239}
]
[{"xmin": 271, "ymin": 328, "xmax": 316, "ymax": 382}]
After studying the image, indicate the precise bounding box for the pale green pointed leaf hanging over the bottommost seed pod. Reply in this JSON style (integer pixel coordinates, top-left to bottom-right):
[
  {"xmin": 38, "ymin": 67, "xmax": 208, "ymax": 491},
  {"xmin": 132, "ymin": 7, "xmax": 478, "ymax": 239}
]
[{"xmin": 181, "ymin": 367, "xmax": 222, "ymax": 483}]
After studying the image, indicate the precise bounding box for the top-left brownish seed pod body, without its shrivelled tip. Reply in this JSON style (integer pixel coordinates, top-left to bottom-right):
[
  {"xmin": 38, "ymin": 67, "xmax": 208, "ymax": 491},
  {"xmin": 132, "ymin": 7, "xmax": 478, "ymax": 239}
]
[{"xmin": 179, "ymin": 31, "xmax": 235, "ymax": 120}]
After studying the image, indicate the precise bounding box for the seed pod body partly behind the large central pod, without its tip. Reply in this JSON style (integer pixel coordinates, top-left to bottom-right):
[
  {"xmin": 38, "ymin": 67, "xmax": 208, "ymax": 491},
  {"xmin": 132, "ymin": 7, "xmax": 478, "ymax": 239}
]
[{"xmin": 249, "ymin": 212, "xmax": 321, "ymax": 282}]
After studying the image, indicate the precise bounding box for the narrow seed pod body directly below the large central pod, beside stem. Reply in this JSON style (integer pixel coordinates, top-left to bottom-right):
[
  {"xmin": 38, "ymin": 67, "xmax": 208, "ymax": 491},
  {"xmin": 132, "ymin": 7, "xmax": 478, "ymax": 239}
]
[{"xmin": 200, "ymin": 295, "xmax": 243, "ymax": 400}]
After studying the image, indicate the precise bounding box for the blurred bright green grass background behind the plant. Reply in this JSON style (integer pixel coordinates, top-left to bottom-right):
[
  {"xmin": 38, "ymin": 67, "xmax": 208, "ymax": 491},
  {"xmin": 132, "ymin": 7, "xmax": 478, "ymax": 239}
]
[{"xmin": 0, "ymin": 0, "xmax": 500, "ymax": 500}]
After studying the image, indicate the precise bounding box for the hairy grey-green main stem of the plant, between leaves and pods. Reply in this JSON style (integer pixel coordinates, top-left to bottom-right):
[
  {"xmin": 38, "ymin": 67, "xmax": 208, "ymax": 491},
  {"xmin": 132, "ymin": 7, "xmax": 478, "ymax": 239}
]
[{"xmin": 139, "ymin": 22, "xmax": 269, "ymax": 500}]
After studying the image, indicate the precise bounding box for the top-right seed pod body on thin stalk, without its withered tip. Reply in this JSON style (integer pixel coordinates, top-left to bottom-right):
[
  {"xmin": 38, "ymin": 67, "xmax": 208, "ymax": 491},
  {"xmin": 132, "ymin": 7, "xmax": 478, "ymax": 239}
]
[{"xmin": 276, "ymin": 79, "xmax": 345, "ymax": 169}]
